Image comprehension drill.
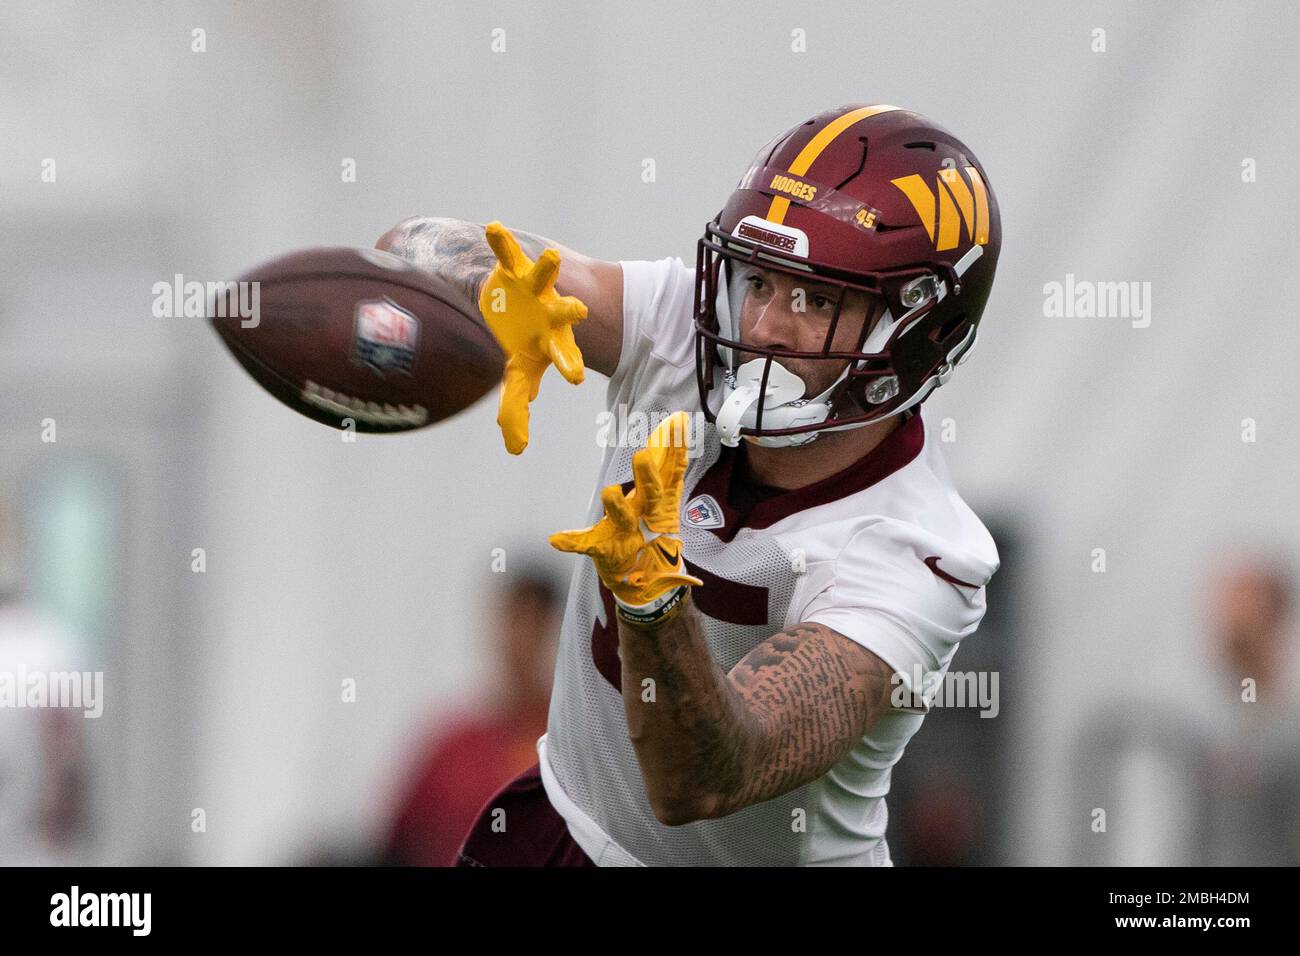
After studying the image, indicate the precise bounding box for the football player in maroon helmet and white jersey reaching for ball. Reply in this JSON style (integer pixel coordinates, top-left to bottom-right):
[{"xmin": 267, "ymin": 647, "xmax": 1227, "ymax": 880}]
[{"xmin": 378, "ymin": 105, "xmax": 1001, "ymax": 865}]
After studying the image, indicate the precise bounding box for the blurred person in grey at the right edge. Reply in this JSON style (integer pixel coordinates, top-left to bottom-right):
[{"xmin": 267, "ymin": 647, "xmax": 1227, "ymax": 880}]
[{"xmin": 1204, "ymin": 557, "xmax": 1300, "ymax": 865}]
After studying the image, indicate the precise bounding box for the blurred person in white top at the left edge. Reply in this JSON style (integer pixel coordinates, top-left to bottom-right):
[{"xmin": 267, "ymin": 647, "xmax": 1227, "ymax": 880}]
[{"xmin": 0, "ymin": 505, "xmax": 85, "ymax": 866}]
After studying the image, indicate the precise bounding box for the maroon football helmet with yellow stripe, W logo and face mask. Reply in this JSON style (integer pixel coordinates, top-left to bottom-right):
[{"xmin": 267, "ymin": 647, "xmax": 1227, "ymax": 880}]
[{"xmin": 696, "ymin": 105, "xmax": 1002, "ymax": 445}]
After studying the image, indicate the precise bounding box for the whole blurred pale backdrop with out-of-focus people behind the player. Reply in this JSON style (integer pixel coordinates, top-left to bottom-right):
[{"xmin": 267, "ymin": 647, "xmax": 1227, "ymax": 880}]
[{"xmin": 0, "ymin": 0, "xmax": 1300, "ymax": 865}]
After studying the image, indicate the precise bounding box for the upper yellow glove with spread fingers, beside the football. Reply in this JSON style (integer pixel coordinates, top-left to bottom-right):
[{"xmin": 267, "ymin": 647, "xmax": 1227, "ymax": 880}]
[{"xmin": 478, "ymin": 222, "xmax": 586, "ymax": 455}]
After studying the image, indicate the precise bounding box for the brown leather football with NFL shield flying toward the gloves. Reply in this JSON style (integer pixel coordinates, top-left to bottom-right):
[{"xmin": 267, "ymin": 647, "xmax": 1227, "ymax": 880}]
[{"xmin": 208, "ymin": 247, "xmax": 504, "ymax": 432}]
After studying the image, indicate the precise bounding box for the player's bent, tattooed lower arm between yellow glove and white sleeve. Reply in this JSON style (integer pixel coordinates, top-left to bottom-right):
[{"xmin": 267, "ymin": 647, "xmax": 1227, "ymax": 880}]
[{"xmin": 619, "ymin": 606, "xmax": 892, "ymax": 823}]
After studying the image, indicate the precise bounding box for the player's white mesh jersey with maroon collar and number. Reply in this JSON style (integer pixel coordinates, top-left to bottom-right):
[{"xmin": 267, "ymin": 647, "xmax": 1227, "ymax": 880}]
[{"xmin": 538, "ymin": 259, "xmax": 998, "ymax": 865}]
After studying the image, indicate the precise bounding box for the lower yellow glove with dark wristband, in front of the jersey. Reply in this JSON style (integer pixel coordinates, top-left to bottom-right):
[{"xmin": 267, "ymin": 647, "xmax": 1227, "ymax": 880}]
[{"xmin": 550, "ymin": 411, "xmax": 702, "ymax": 624}]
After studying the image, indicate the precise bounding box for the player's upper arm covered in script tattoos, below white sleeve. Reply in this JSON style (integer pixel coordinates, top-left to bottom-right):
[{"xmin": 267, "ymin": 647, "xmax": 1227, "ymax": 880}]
[{"xmin": 728, "ymin": 623, "xmax": 893, "ymax": 793}]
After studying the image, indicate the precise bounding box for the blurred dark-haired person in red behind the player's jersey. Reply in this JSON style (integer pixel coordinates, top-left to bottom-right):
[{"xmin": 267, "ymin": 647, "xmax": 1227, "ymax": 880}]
[{"xmin": 385, "ymin": 568, "xmax": 563, "ymax": 866}]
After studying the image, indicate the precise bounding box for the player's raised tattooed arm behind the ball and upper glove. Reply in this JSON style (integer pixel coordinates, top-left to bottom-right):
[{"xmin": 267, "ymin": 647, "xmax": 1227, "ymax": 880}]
[{"xmin": 374, "ymin": 216, "xmax": 623, "ymax": 376}]
